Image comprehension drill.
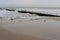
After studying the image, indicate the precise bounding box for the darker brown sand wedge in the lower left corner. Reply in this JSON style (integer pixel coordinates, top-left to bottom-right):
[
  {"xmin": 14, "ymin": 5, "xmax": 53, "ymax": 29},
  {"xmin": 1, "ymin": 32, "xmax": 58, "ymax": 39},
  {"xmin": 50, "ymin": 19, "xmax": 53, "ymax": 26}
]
[{"xmin": 0, "ymin": 22, "xmax": 41, "ymax": 40}]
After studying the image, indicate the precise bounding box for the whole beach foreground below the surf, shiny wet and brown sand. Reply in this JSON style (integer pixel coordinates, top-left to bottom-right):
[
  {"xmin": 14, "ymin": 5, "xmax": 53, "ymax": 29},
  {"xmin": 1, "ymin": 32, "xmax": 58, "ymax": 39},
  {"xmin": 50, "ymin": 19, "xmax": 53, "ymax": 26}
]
[{"xmin": 0, "ymin": 19, "xmax": 60, "ymax": 40}]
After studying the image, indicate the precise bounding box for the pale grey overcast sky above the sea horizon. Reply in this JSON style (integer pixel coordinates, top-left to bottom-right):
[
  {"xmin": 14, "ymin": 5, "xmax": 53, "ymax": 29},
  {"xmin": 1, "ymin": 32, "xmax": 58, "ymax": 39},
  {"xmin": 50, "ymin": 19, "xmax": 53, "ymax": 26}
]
[{"xmin": 0, "ymin": 0, "xmax": 60, "ymax": 7}]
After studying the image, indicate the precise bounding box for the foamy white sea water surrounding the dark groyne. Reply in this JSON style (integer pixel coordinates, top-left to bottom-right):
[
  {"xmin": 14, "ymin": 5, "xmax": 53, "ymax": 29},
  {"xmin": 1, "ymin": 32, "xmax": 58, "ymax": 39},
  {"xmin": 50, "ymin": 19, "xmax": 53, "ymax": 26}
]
[{"xmin": 0, "ymin": 8, "xmax": 60, "ymax": 20}]
